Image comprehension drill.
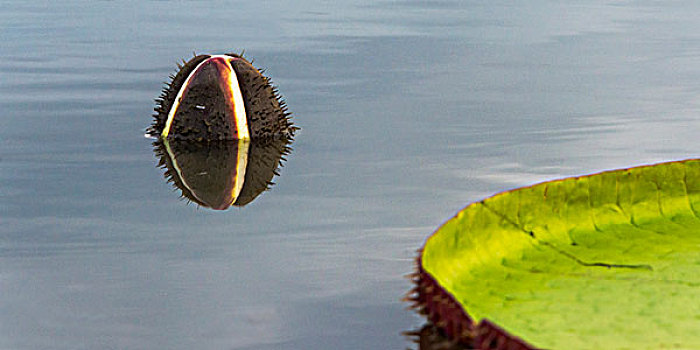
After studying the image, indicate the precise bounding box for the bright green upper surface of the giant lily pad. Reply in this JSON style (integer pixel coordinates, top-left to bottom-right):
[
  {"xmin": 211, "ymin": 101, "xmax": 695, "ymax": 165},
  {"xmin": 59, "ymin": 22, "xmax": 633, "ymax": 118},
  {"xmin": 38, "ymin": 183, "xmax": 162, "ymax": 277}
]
[{"xmin": 422, "ymin": 160, "xmax": 700, "ymax": 349}]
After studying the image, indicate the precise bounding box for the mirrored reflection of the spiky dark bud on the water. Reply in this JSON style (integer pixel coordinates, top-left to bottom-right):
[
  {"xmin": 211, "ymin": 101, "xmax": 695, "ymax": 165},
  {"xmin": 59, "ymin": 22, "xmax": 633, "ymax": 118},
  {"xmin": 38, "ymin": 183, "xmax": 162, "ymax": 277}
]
[{"xmin": 153, "ymin": 139, "xmax": 291, "ymax": 210}]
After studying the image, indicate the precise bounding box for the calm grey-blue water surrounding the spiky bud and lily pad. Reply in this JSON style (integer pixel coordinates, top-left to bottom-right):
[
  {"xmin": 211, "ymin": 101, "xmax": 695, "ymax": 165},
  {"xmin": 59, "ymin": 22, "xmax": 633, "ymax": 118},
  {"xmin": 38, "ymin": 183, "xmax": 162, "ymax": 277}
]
[{"xmin": 0, "ymin": 1, "xmax": 700, "ymax": 349}]
